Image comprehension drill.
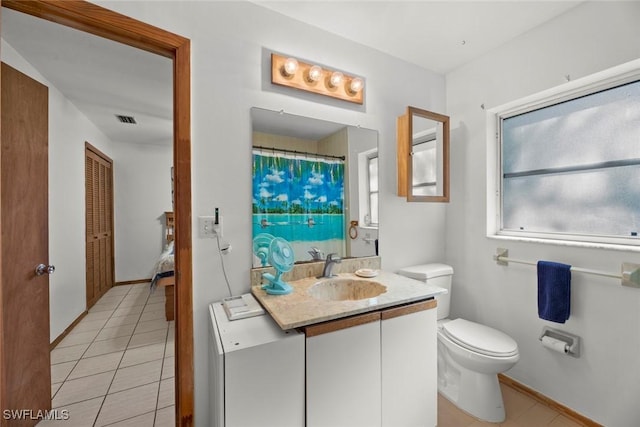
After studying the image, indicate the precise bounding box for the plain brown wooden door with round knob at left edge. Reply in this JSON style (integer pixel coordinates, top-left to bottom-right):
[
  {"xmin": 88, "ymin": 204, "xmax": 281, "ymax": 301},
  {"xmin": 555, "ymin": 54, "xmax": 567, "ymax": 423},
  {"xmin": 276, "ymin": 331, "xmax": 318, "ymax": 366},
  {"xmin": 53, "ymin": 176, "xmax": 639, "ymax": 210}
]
[{"xmin": 0, "ymin": 63, "xmax": 51, "ymax": 426}]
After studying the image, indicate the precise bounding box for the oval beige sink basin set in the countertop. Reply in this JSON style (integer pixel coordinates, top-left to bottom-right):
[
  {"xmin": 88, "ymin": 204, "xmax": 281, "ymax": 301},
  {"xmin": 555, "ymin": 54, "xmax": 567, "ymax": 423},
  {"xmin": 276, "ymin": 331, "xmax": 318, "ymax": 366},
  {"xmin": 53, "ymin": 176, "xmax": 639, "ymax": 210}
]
[{"xmin": 308, "ymin": 278, "xmax": 387, "ymax": 301}]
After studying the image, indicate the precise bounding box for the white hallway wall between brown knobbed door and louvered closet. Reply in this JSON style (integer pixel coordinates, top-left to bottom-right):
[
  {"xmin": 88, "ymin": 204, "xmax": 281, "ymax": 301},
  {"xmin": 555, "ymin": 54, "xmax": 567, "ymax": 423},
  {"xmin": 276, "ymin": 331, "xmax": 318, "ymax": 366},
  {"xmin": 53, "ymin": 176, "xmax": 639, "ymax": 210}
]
[{"xmin": 1, "ymin": 40, "xmax": 111, "ymax": 341}]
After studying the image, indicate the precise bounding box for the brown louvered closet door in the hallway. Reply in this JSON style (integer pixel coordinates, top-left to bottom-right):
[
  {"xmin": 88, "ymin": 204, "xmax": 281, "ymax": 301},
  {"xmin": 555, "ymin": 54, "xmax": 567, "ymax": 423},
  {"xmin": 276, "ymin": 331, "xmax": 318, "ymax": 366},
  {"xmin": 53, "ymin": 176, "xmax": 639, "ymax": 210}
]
[{"xmin": 85, "ymin": 144, "xmax": 114, "ymax": 308}]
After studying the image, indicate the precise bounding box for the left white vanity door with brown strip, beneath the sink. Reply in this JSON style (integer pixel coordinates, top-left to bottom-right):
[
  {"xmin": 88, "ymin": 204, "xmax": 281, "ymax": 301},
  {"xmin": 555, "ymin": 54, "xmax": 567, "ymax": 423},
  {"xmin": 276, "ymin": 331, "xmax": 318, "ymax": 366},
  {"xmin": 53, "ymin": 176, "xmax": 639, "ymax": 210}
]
[{"xmin": 305, "ymin": 313, "xmax": 380, "ymax": 427}]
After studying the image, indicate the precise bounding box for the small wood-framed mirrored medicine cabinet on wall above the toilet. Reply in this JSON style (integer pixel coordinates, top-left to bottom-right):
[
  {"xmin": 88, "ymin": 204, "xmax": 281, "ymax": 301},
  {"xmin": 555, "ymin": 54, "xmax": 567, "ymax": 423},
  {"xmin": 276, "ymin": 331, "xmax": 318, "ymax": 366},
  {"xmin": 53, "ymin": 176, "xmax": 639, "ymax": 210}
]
[{"xmin": 397, "ymin": 107, "xmax": 449, "ymax": 202}]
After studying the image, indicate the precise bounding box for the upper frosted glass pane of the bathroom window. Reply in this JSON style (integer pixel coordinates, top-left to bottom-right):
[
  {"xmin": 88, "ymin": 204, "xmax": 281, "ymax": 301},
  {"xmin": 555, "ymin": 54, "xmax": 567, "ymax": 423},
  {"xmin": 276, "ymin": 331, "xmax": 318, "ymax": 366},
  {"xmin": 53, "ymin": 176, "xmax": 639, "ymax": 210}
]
[{"xmin": 502, "ymin": 82, "xmax": 640, "ymax": 173}]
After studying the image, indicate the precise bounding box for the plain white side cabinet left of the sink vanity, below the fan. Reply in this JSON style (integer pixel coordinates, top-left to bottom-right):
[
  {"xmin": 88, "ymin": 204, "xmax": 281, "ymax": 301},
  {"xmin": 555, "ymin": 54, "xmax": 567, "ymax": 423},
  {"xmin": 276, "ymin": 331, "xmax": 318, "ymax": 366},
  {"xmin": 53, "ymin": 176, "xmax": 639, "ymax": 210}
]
[{"xmin": 209, "ymin": 303, "xmax": 305, "ymax": 427}]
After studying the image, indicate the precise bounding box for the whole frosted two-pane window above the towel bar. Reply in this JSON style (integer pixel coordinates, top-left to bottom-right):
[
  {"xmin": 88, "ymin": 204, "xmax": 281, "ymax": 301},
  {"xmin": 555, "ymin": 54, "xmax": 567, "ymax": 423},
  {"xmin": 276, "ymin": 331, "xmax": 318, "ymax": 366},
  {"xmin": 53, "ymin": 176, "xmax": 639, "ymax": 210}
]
[{"xmin": 496, "ymin": 62, "xmax": 640, "ymax": 245}]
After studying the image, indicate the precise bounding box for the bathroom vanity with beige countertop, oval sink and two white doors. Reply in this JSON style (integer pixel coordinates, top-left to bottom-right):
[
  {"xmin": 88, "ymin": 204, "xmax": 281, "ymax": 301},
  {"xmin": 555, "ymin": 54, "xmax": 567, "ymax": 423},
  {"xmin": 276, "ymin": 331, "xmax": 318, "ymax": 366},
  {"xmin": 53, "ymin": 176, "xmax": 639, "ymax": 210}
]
[{"xmin": 252, "ymin": 272, "xmax": 445, "ymax": 427}]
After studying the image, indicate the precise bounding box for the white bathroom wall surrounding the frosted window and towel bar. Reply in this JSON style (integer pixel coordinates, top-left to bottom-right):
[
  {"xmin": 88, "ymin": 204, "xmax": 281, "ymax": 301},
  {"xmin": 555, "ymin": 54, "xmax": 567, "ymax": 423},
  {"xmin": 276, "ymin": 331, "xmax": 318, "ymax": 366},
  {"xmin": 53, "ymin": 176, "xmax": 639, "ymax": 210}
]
[{"xmin": 444, "ymin": 2, "xmax": 640, "ymax": 427}]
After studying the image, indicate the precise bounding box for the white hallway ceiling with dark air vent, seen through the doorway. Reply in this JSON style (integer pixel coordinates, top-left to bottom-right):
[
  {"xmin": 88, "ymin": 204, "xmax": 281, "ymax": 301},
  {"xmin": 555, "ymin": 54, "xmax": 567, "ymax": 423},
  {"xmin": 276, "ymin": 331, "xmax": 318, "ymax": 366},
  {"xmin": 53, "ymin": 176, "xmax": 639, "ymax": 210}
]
[{"xmin": 2, "ymin": 8, "xmax": 173, "ymax": 145}]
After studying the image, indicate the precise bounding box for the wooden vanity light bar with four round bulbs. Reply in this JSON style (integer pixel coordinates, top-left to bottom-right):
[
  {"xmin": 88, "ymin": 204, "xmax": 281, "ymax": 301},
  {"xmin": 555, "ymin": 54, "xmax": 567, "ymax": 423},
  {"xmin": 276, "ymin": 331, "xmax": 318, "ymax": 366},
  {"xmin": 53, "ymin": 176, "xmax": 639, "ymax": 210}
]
[{"xmin": 271, "ymin": 53, "xmax": 364, "ymax": 104}]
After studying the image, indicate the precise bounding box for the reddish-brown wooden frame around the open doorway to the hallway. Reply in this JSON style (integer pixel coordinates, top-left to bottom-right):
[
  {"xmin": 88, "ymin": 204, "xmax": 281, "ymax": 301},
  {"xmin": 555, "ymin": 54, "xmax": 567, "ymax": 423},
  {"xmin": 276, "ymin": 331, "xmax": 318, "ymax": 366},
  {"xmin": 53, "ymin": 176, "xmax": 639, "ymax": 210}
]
[{"xmin": 0, "ymin": 0, "xmax": 194, "ymax": 427}]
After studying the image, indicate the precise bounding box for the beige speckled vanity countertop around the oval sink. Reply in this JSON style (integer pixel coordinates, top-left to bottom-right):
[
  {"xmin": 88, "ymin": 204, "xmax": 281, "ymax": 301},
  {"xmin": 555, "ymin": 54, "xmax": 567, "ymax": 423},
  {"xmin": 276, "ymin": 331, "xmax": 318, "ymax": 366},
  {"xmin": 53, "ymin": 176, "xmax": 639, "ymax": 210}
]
[{"xmin": 251, "ymin": 271, "xmax": 447, "ymax": 330}]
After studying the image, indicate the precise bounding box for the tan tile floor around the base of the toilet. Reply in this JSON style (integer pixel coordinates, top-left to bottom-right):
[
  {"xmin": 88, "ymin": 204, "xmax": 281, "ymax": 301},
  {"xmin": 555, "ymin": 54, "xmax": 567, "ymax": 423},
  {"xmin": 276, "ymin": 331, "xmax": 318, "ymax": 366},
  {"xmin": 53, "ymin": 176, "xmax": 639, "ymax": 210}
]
[{"xmin": 438, "ymin": 384, "xmax": 582, "ymax": 427}]
